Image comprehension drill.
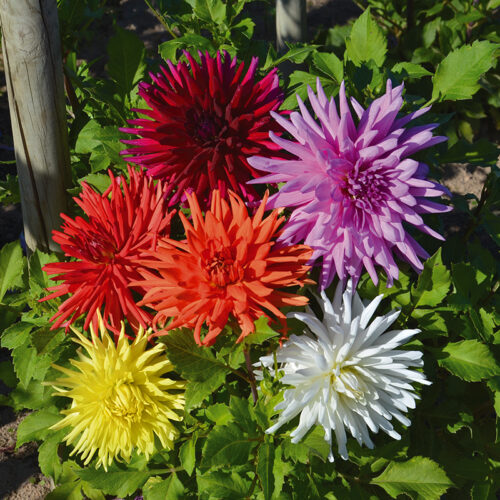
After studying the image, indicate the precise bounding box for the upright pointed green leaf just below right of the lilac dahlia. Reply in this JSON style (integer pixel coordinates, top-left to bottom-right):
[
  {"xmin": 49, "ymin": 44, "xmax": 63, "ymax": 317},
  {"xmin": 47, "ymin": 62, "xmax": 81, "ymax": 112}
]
[{"xmin": 412, "ymin": 248, "xmax": 451, "ymax": 308}]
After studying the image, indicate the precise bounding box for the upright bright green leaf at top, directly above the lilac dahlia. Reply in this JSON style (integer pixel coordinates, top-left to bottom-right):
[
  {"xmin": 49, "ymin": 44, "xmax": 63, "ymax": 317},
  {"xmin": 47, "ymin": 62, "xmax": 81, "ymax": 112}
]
[{"xmin": 345, "ymin": 8, "xmax": 387, "ymax": 66}]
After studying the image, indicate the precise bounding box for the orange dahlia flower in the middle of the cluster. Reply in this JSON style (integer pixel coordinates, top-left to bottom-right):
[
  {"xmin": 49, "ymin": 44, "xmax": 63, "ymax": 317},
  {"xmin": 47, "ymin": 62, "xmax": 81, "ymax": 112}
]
[{"xmin": 132, "ymin": 191, "xmax": 312, "ymax": 345}]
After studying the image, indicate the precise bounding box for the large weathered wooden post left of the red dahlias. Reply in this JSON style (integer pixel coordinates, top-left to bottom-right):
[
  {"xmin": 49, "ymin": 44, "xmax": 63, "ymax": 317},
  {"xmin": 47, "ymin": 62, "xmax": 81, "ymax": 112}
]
[{"xmin": 0, "ymin": 0, "xmax": 70, "ymax": 252}]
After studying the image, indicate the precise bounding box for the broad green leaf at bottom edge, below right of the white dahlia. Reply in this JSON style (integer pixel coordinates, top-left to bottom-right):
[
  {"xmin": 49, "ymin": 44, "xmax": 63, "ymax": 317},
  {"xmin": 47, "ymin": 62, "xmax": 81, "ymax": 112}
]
[{"xmin": 371, "ymin": 457, "xmax": 453, "ymax": 500}]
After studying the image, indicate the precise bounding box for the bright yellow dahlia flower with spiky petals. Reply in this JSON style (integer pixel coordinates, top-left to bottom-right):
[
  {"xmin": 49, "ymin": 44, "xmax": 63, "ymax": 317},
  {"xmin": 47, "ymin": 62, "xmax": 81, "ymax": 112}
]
[{"xmin": 51, "ymin": 315, "xmax": 185, "ymax": 470}]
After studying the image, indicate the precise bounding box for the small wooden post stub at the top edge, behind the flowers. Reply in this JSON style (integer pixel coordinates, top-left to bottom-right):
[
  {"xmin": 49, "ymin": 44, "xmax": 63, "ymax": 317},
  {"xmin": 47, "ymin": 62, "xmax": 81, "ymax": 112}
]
[{"xmin": 276, "ymin": 0, "xmax": 307, "ymax": 53}]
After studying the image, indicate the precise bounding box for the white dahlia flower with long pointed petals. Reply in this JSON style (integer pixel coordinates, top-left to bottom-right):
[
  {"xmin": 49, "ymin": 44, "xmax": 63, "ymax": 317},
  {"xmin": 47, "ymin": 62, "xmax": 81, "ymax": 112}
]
[{"xmin": 257, "ymin": 280, "xmax": 430, "ymax": 462}]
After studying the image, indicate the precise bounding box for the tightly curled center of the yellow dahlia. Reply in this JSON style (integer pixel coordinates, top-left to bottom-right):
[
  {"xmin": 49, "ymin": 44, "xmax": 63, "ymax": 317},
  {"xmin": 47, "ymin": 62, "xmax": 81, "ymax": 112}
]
[{"xmin": 104, "ymin": 374, "xmax": 145, "ymax": 424}]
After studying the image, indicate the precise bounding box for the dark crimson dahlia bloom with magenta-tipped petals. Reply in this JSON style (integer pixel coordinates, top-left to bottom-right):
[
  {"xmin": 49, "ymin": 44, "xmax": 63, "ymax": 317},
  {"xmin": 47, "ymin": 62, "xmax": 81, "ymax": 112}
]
[{"xmin": 121, "ymin": 52, "xmax": 283, "ymax": 208}]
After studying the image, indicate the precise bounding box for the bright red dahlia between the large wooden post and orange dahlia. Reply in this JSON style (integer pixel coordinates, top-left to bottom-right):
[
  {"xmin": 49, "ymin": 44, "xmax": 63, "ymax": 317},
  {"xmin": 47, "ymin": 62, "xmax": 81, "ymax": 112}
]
[{"xmin": 42, "ymin": 167, "xmax": 172, "ymax": 333}]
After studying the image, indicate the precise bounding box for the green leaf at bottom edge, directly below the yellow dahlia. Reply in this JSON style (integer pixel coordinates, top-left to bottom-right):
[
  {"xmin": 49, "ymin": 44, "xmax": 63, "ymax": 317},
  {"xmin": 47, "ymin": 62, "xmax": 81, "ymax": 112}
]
[{"xmin": 75, "ymin": 466, "xmax": 151, "ymax": 497}]
